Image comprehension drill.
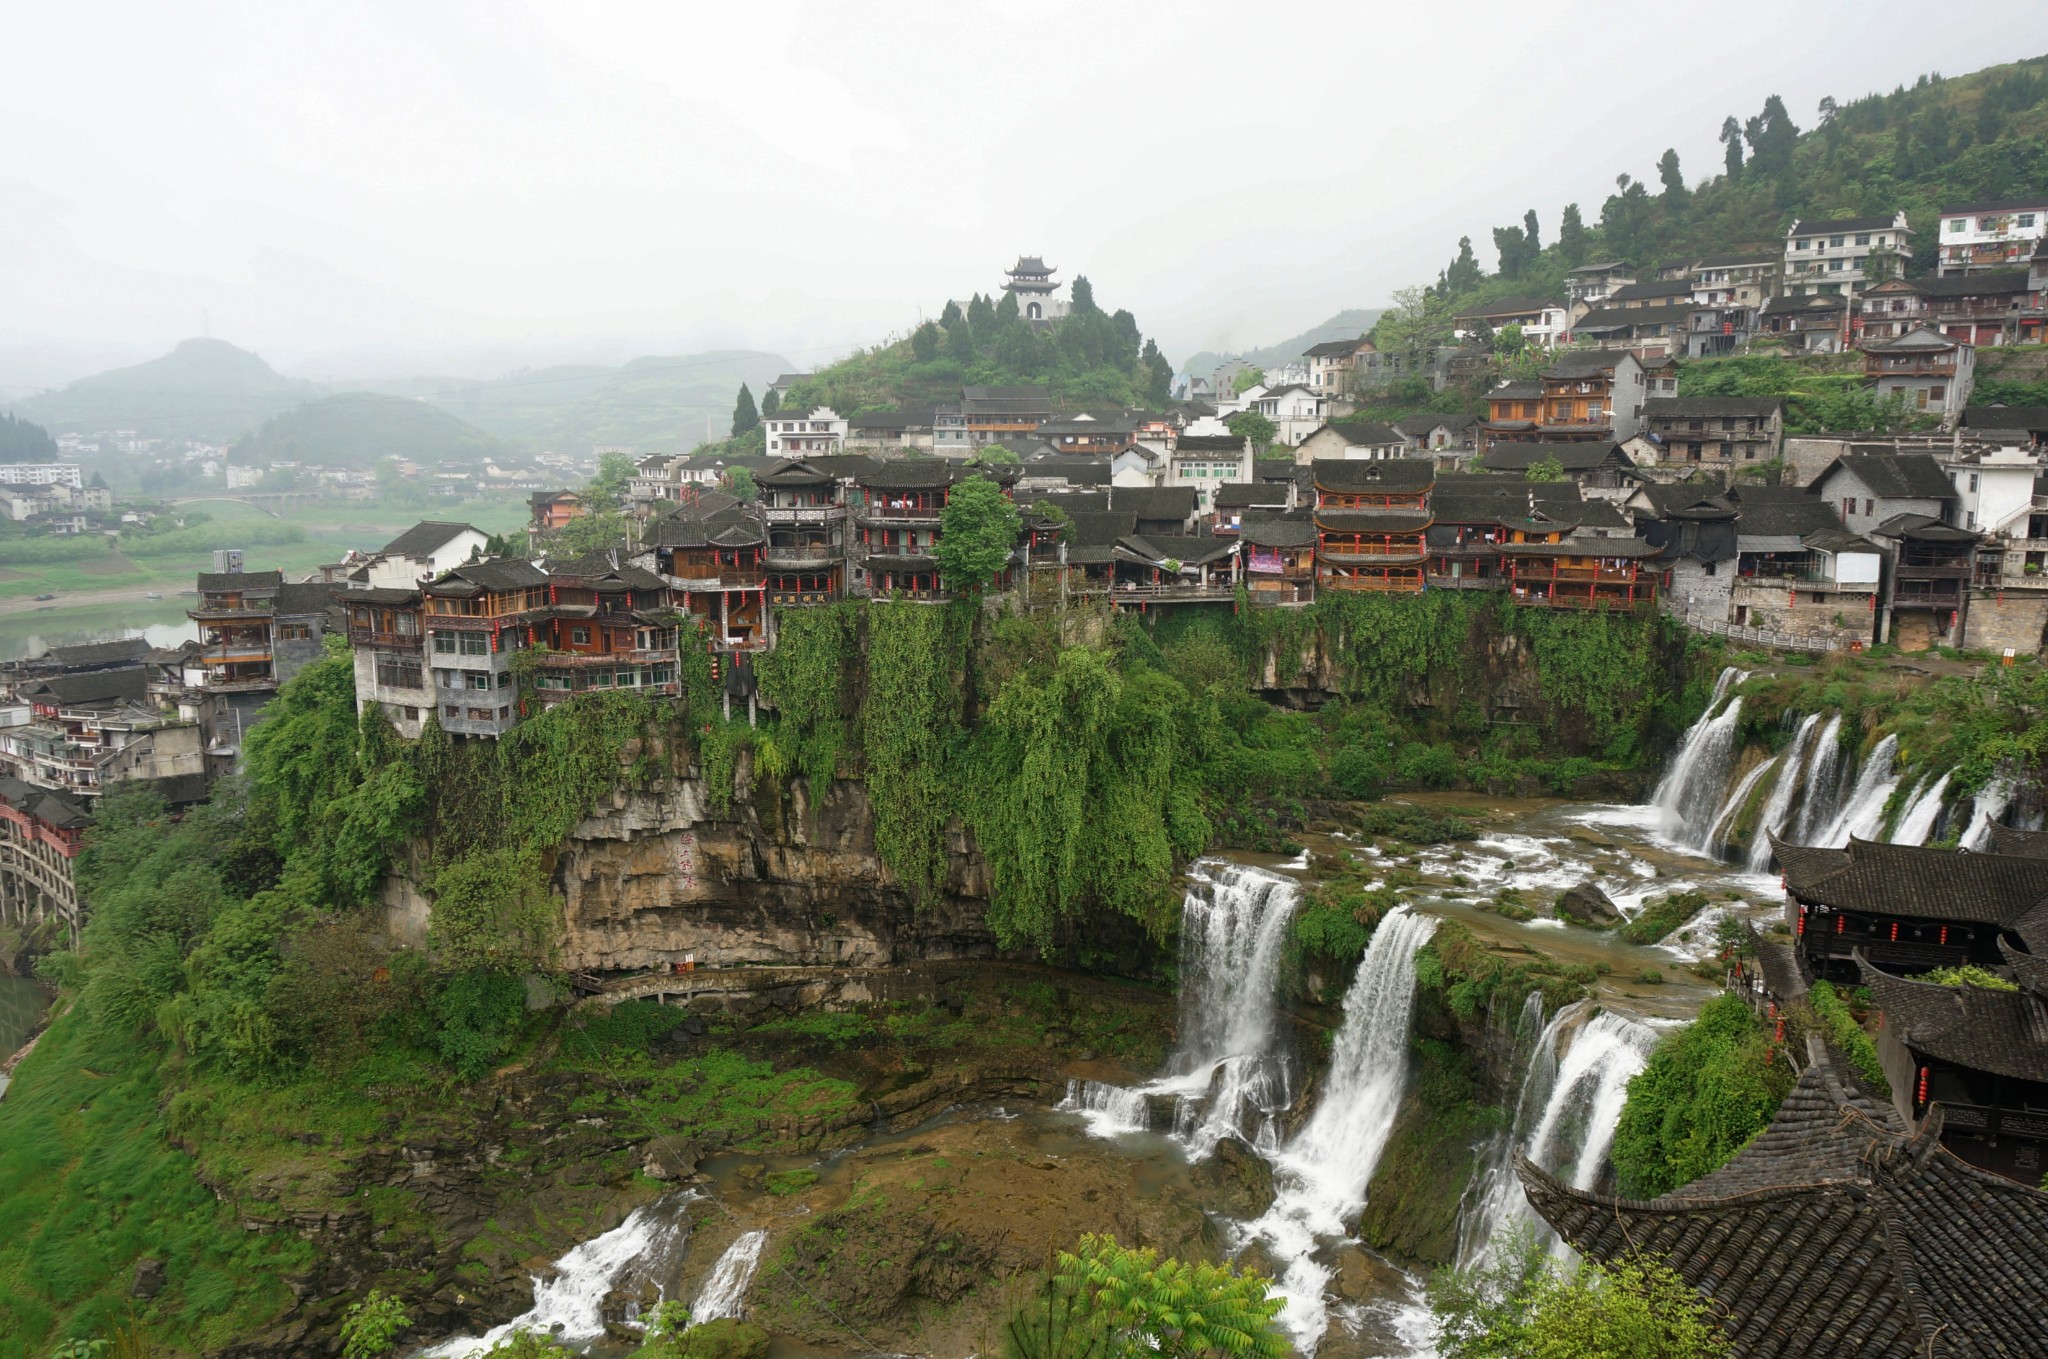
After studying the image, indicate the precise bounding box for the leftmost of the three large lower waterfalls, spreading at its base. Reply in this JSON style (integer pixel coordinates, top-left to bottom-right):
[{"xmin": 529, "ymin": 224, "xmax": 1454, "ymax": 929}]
[{"xmin": 1059, "ymin": 860, "xmax": 1300, "ymax": 1160}]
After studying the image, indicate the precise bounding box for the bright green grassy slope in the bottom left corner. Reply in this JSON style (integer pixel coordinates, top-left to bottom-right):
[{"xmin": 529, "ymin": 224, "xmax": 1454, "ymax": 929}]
[{"xmin": 0, "ymin": 1013, "xmax": 311, "ymax": 1359}]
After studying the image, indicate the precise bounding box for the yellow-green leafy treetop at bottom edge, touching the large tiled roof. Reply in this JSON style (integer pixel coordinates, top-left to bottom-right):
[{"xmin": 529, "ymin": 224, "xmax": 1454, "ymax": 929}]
[{"xmin": 1430, "ymin": 1240, "xmax": 1733, "ymax": 1359}]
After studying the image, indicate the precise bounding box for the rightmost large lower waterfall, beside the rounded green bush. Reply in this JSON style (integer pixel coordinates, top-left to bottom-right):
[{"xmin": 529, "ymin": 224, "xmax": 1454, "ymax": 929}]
[{"xmin": 1458, "ymin": 1001, "xmax": 1657, "ymax": 1269}]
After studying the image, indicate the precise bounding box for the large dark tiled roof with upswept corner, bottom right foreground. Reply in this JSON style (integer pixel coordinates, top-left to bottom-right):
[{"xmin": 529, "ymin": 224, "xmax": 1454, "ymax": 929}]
[{"xmin": 1516, "ymin": 1046, "xmax": 2048, "ymax": 1359}]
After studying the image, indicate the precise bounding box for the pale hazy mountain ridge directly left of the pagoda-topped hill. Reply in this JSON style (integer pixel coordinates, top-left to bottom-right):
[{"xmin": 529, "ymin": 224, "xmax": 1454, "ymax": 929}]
[{"xmin": 354, "ymin": 350, "xmax": 795, "ymax": 454}]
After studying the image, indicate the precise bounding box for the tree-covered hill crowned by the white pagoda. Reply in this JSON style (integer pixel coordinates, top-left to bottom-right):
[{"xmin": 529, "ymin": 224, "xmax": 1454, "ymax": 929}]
[{"xmin": 770, "ymin": 276, "xmax": 1174, "ymax": 425}]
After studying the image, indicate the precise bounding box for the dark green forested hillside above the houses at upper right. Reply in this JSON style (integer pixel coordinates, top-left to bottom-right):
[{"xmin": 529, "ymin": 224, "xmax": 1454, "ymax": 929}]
[{"xmin": 1378, "ymin": 57, "xmax": 2048, "ymax": 348}]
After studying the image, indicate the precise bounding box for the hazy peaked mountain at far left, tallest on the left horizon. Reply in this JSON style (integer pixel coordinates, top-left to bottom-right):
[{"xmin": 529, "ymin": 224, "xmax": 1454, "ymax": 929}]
[{"xmin": 14, "ymin": 340, "xmax": 317, "ymax": 442}]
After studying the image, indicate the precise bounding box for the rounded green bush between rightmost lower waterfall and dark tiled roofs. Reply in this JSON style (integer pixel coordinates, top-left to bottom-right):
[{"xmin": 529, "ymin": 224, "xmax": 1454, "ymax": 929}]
[{"xmin": 1612, "ymin": 995, "xmax": 1792, "ymax": 1199}]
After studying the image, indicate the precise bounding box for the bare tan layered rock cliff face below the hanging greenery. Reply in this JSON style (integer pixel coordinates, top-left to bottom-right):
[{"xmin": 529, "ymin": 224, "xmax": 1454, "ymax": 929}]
[{"xmin": 555, "ymin": 749, "xmax": 995, "ymax": 970}]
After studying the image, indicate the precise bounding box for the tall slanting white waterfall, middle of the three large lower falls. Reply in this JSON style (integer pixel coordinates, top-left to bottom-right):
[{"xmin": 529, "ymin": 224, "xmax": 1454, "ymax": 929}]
[{"xmin": 1243, "ymin": 907, "xmax": 1436, "ymax": 1359}]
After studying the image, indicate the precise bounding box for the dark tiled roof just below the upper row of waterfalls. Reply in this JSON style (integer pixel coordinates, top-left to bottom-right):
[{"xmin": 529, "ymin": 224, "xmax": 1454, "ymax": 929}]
[{"xmin": 1780, "ymin": 839, "xmax": 2048, "ymax": 925}]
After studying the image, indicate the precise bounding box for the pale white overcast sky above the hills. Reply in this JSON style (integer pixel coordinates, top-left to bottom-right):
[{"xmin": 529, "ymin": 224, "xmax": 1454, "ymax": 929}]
[{"xmin": 0, "ymin": 0, "xmax": 2048, "ymax": 393}]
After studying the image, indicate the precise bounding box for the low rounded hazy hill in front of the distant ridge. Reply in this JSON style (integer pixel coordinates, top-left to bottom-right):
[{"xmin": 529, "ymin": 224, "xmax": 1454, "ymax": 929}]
[{"xmin": 227, "ymin": 391, "xmax": 502, "ymax": 469}]
